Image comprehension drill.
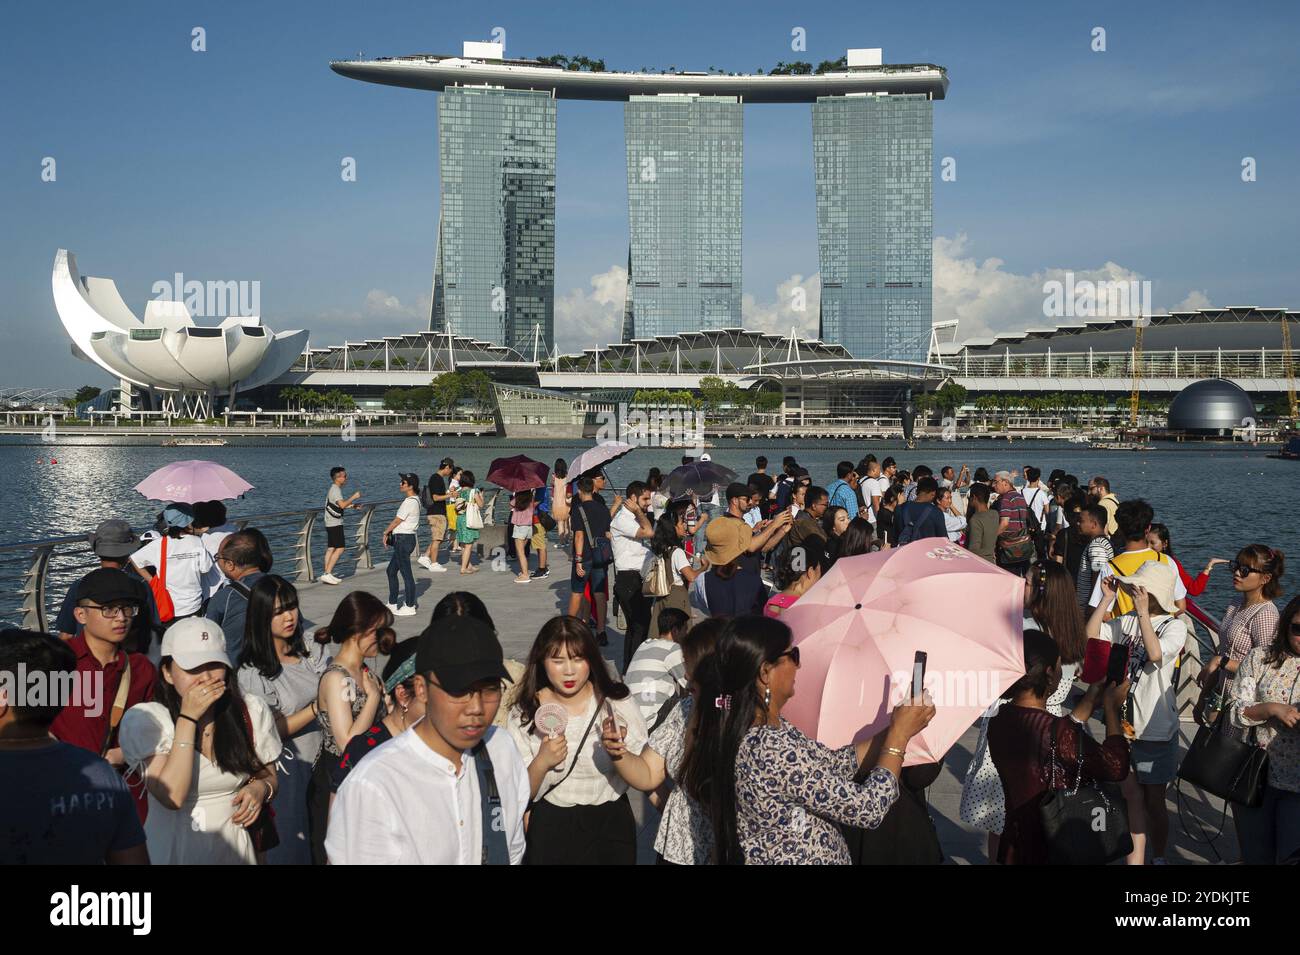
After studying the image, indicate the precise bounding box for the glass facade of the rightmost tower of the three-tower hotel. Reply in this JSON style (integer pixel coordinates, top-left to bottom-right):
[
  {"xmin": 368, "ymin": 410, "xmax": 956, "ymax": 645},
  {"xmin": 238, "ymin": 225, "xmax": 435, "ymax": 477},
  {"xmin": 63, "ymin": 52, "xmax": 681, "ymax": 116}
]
[{"xmin": 813, "ymin": 94, "xmax": 933, "ymax": 361}]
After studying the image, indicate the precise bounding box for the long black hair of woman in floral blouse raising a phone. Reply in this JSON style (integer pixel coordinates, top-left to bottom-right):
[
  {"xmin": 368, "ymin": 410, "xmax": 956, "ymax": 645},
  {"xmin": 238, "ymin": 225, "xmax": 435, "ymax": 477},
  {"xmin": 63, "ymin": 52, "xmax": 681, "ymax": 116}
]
[{"xmin": 679, "ymin": 616, "xmax": 792, "ymax": 865}]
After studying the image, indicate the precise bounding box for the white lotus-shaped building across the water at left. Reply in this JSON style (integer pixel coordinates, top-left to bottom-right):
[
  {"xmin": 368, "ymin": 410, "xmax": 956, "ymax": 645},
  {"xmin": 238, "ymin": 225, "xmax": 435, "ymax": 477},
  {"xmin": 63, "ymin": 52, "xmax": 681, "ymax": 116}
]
[{"xmin": 52, "ymin": 248, "xmax": 309, "ymax": 404}]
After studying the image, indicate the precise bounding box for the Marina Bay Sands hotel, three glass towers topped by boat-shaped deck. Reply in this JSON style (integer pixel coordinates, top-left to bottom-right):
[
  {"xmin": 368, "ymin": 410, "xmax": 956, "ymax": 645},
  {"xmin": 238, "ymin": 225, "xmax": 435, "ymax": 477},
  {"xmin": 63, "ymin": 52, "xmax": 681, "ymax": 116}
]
[{"xmin": 330, "ymin": 43, "xmax": 948, "ymax": 363}]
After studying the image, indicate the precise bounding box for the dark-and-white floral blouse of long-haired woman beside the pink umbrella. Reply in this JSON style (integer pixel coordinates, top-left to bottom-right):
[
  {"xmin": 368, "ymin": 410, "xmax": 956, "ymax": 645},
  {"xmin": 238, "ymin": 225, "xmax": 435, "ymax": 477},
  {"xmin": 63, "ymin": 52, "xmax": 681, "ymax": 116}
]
[{"xmin": 736, "ymin": 720, "xmax": 898, "ymax": 865}]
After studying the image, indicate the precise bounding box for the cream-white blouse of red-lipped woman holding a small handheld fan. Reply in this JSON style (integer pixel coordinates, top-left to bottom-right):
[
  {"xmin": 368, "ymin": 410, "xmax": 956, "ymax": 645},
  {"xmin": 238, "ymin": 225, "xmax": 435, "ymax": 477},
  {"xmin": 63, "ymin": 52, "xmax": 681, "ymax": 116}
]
[{"xmin": 506, "ymin": 693, "xmax": 647, "ymax": 808}]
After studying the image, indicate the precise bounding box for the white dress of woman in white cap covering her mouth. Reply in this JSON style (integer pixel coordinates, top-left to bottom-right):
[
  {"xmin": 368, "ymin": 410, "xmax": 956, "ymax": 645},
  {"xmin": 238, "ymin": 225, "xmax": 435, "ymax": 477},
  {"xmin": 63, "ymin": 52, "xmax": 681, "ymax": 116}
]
[{"xmin": 118, "ymin": 695, "xmax": 282, "ymax": 865}]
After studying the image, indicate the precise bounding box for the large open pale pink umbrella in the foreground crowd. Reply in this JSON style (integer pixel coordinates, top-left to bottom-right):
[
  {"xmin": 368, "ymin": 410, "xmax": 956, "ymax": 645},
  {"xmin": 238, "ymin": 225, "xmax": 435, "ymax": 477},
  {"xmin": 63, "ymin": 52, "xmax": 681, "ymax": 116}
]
[{"xmin": 781, "ymin": 538, "xmax": 1024, "ymax": 765}]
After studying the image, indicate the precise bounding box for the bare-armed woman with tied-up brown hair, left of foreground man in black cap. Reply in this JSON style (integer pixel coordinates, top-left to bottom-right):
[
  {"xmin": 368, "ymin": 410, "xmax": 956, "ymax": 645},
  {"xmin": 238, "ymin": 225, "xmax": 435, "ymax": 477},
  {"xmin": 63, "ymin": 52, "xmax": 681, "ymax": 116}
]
[{"xmin": 315, "ymin": 590, "xmax": 394, "ymax": 790}]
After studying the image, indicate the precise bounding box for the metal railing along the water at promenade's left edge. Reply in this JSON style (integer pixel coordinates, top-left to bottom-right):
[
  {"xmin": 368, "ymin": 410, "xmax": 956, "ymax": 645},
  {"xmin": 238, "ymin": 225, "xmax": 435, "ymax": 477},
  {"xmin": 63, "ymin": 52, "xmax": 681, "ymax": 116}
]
[{"xmin": 0, "ymin": 489, "xmax": 527, "ymax": 631}]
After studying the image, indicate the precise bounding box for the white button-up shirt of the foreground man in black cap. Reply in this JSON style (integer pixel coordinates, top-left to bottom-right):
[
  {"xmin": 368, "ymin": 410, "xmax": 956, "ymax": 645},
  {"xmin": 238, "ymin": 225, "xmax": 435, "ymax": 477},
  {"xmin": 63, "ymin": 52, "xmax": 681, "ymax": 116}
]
[{"xmin": 325, "ymin": 726, "xmax": 529, "ymax": 865}]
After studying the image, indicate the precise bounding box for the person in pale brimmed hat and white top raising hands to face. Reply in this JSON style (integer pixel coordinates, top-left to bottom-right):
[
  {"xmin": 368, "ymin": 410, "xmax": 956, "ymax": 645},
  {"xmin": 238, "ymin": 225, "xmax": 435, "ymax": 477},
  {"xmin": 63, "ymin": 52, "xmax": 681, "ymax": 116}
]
[{"xmin": 1088, "ymin": 561, "xmax": 1187, "ymax": 865}]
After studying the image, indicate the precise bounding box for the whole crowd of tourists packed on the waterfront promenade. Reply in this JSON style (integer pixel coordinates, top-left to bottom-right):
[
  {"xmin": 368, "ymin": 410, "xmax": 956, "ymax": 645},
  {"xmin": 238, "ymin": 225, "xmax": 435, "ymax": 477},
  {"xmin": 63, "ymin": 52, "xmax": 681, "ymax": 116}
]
[{"xmin": 0, "ymin": 455, "xmax": 1300, "ymax": 865}]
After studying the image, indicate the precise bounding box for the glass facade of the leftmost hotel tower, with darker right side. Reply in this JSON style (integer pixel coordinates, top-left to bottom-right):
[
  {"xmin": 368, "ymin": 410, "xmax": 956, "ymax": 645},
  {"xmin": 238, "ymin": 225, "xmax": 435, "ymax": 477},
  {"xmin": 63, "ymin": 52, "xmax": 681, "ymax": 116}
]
[{"xmin": 429, "ymin": 87, "xmax": 555, "ymax": 356}]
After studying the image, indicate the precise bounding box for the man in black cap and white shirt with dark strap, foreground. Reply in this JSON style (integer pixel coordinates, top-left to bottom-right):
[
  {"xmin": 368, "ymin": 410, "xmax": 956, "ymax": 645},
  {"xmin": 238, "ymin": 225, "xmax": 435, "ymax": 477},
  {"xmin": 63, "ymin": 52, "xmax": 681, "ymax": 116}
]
[{"xmin": 325, "ymin": 617, "xmax": 529, "ymax": 865}]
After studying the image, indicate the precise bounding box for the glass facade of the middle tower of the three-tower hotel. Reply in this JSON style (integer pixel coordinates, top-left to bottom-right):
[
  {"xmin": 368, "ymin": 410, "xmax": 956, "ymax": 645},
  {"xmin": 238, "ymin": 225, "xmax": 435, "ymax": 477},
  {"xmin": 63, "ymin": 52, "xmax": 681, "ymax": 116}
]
[{"xmin": 623, "ymin": 95, "xmax": 744, "ymax": 342}]
